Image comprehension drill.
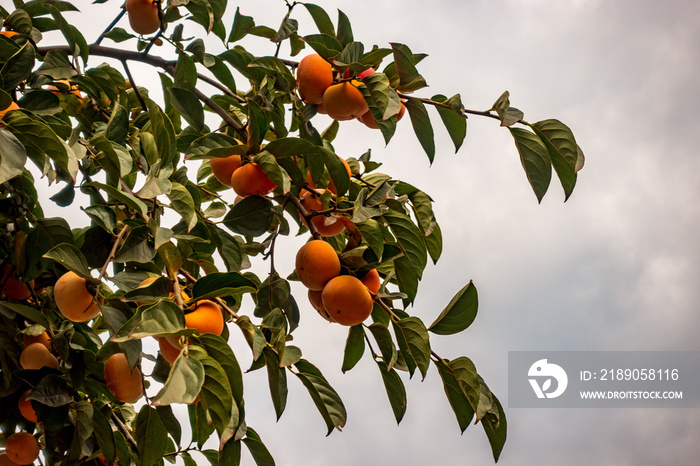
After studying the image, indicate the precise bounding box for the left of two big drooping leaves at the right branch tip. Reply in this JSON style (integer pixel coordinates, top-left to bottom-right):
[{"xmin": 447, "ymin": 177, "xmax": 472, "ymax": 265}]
[{"xmin": 508, "ymin": 128, "xmax": 552, "ymax": 202}]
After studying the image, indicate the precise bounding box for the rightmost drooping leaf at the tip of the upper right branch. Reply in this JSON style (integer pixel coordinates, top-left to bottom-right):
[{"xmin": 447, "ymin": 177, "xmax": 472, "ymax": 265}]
[{"xmin": 530, "ymin": 120, "xmax": 578, "ymax": 202}]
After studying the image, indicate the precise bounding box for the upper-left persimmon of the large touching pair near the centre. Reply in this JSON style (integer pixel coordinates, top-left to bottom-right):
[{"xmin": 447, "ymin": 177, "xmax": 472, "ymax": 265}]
[{"xmin": 296, "ymin": 239, "xmax": 340, "ymax": 291}]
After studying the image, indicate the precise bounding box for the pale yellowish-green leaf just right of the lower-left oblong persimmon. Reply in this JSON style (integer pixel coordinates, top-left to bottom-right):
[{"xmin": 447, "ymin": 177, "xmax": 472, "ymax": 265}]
[{"xmin": 151, "ymin": 355, "xmax": 204, "ymax": 406}]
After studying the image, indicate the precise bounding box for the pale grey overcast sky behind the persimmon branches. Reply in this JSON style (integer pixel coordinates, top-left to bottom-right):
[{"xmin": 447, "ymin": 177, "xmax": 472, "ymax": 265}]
[{"xmin": 37, "ymin": 0, "xmax": 700, "ymax": 466}]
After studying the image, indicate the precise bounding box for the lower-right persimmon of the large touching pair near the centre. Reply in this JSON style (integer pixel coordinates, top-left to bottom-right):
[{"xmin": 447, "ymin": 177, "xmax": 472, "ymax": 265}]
[{"xmin": 321, "ymin": 275, "xmax": 373, "ymax": 326}]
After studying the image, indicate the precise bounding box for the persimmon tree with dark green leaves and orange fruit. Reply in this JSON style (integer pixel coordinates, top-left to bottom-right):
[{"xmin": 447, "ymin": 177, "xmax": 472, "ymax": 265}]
[{"xmin": 0, "ymin": 0, "xmax": 583, "ymax": 465}]
